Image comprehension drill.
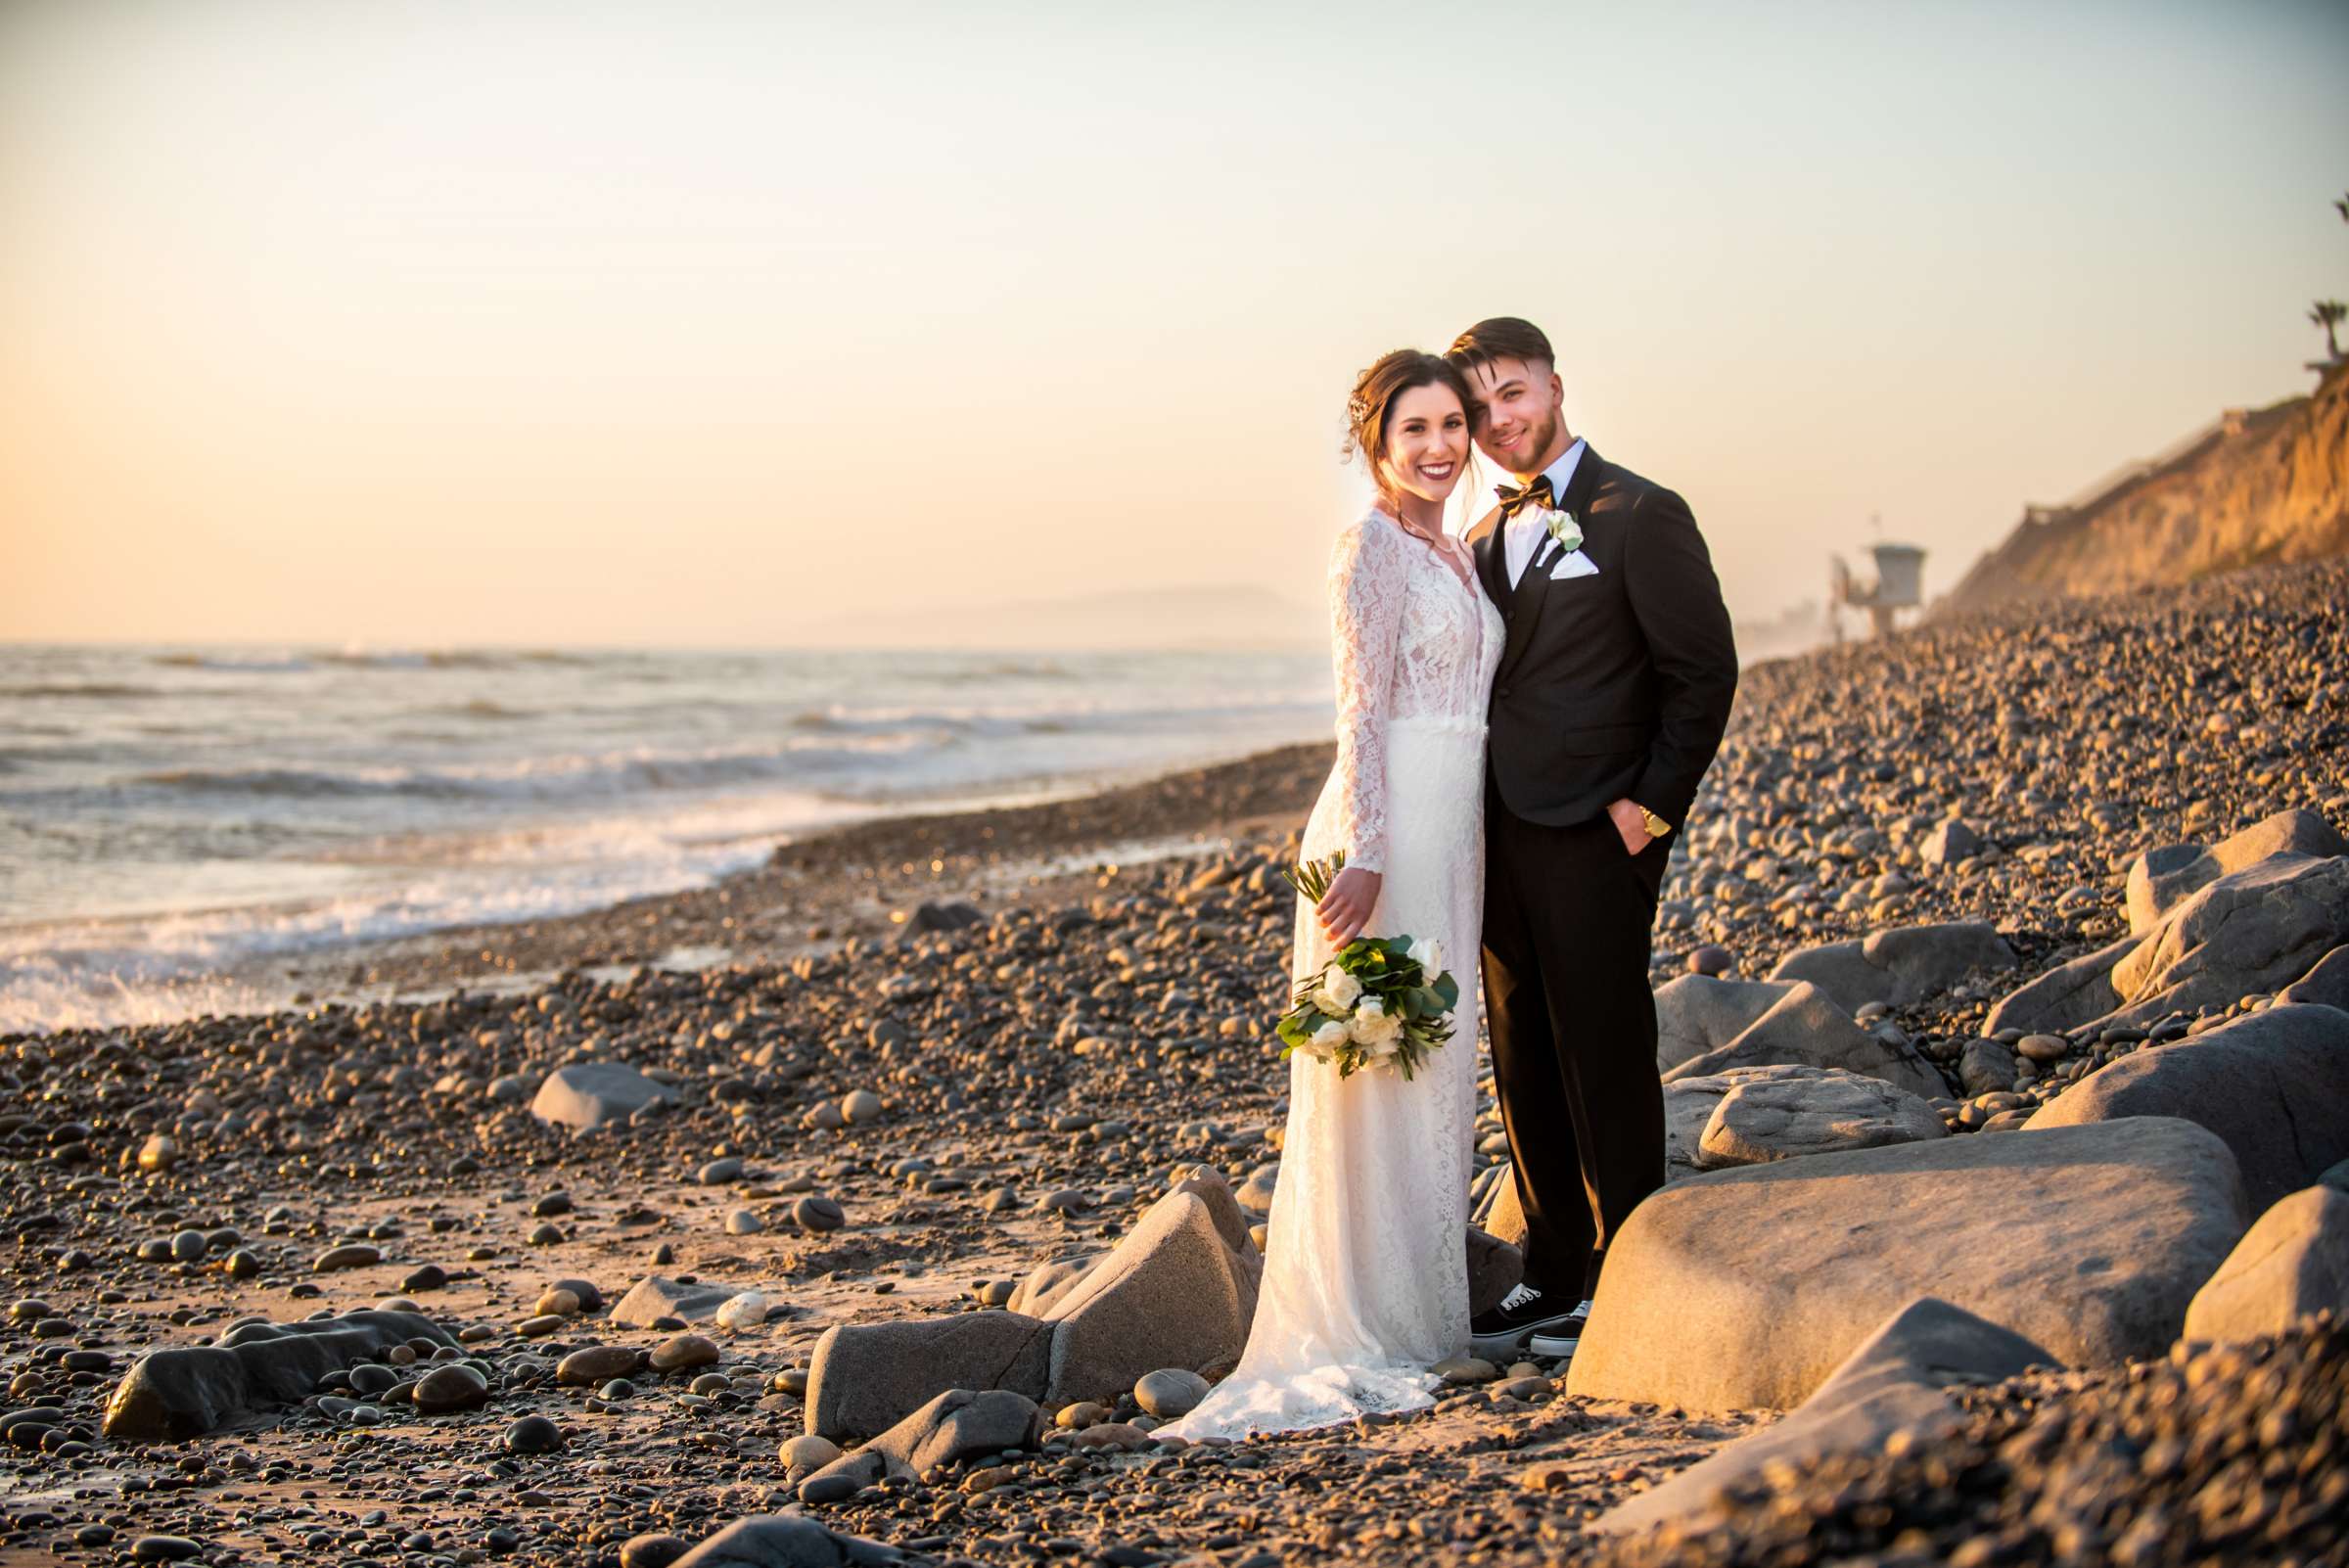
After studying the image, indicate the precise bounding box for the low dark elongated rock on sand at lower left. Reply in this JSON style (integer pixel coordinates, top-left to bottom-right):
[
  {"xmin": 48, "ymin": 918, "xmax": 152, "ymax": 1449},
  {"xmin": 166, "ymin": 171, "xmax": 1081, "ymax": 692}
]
[{"xmin": 104, "ymin": 1313, "xmax": 456, "ymax": 1444}]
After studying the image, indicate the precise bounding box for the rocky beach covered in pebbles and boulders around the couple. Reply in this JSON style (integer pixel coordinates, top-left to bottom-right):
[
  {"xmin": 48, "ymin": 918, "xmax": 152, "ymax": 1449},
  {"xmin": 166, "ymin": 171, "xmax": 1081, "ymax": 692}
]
[{"xmin": 0, "ymin": 566, "xmax": 2349, "ymax": 1568}]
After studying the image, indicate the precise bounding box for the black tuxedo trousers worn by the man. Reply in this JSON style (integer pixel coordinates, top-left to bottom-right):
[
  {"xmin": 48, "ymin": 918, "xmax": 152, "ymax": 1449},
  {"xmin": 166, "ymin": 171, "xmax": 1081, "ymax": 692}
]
[{"xmin": 1485, "ymin": 784, "xmax": 1670, "ymax": 1301}]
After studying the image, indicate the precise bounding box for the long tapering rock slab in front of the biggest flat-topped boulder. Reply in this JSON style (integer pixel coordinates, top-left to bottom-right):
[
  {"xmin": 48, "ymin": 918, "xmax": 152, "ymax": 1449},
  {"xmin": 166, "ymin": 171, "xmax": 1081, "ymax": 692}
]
[{"xmin": 1595, "ymin": 1296, "xmax": 2055, "ymax": 1535}]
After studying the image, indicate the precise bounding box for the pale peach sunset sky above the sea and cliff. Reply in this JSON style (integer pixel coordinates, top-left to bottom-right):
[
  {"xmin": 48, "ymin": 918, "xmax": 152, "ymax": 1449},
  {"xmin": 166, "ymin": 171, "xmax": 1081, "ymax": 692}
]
[{"xmin": 0, "ymin": 0, "xmax": 2349, "ymax": 646}]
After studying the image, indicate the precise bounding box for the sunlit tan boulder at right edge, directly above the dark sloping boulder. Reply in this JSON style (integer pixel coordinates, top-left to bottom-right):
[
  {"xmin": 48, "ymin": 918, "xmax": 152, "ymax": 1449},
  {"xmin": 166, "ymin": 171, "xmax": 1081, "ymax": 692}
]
[{"xmin": 2109, "ymin": 854, "xmax": 2349, "ymax": 1026}]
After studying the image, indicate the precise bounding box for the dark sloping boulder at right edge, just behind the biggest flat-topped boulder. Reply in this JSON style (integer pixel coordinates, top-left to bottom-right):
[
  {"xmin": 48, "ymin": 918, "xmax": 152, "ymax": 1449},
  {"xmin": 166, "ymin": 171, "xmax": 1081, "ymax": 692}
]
[{"xmin": 2022, "ymin": 1007, "xmax": 2349, "ymax": 1214}]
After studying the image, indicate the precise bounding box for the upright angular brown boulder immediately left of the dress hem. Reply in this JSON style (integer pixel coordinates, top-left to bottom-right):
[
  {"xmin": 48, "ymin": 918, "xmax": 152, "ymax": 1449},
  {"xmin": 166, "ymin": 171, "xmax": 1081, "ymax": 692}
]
[{"xmin": 1045, "ymin": 1169, "xmax": 1264, "ymax": 1399}]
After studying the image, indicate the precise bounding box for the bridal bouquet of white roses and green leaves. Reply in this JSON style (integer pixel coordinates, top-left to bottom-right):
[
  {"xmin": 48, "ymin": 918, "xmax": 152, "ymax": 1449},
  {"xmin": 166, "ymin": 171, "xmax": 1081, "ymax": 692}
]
[{"xmin": 1273, "ymin": 853, "xmax": 1461, "ymax": 1080}]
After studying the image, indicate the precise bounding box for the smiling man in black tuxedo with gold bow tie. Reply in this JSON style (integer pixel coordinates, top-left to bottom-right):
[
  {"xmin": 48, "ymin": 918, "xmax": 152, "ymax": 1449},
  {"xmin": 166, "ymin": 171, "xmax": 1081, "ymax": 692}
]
[{"xmin": 1445, "ymin": 317, "xmax": 1738, "ymax": 1357}]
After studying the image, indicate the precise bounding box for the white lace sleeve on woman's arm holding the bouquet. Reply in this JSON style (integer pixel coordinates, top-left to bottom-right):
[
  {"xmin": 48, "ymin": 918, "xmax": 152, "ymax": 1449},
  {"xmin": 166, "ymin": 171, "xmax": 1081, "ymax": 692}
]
[{"xmin": 1329, "ymin": 519, "xmax": 1405, "ymax": 871}]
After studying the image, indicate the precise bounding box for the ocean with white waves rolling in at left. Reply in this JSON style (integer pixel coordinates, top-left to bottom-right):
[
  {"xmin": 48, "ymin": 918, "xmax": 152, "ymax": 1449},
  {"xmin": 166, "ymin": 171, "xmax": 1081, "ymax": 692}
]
[{"xmin": 0, "ymin": 646, "xmax": 1332, "ymax": 1033}]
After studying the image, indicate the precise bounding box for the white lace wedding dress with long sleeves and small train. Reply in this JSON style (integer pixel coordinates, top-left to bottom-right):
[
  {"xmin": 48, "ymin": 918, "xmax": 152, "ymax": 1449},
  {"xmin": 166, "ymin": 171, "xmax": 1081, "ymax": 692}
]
[{"xmin": 1165, "ymin": 512, "xmax": 1501, "ymax": 1439}]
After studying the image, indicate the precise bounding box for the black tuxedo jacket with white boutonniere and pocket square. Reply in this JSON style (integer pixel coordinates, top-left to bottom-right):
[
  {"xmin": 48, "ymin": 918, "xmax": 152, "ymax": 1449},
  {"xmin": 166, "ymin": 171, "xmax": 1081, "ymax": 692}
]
[{"xmin": 1468, "ymin": 446, "xmax": 1738, "ymax": 826}]
